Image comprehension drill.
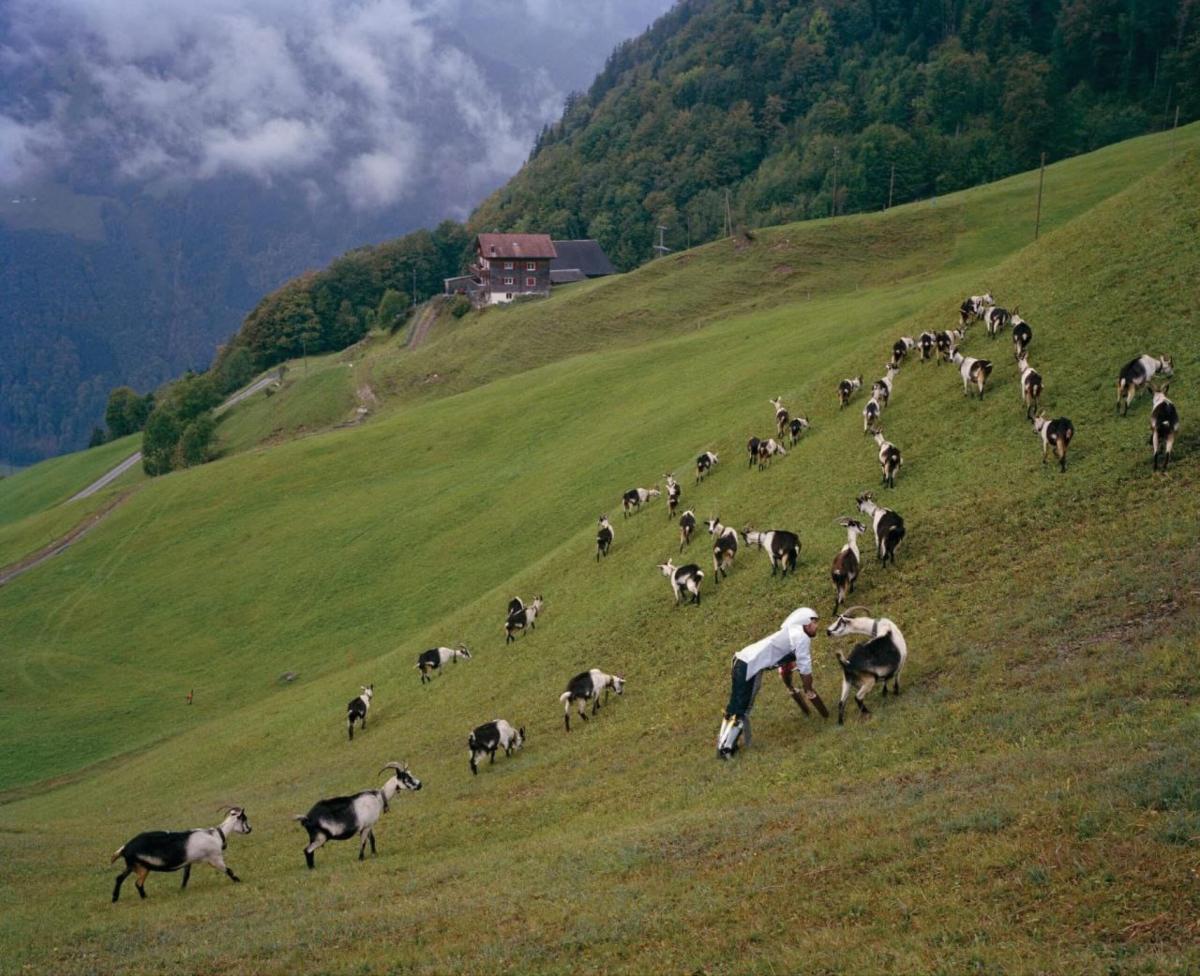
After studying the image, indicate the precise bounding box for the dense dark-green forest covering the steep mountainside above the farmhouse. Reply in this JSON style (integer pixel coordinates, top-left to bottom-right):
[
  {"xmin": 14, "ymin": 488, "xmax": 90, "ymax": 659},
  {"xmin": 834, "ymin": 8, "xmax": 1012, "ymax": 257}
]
[{"xmin": 470, "ymin": 0, "xmax": 1200, "ymax": 268}]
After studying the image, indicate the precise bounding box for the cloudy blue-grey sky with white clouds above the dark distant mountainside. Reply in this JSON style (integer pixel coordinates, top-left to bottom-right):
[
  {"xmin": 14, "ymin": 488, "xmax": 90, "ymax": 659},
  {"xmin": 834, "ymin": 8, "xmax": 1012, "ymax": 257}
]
[{"xmin": 0, "ymin": 0, "xmax": 671, "ymax": 211}]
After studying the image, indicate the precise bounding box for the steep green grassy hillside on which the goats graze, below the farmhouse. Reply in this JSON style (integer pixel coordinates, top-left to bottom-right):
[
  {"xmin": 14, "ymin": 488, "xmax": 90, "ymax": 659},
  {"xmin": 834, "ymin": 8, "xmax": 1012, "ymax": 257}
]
[{"xmin": 0, "ymin": 131, "xmax": 1200, "ymax": 974}]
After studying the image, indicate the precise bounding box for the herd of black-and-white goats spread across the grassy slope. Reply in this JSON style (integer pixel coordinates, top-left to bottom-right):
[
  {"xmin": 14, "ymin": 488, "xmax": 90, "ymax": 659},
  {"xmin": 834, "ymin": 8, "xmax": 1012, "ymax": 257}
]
[{"xmin": 112, "ymin": 294, "xmax": 1180, "ymax": 902}]
